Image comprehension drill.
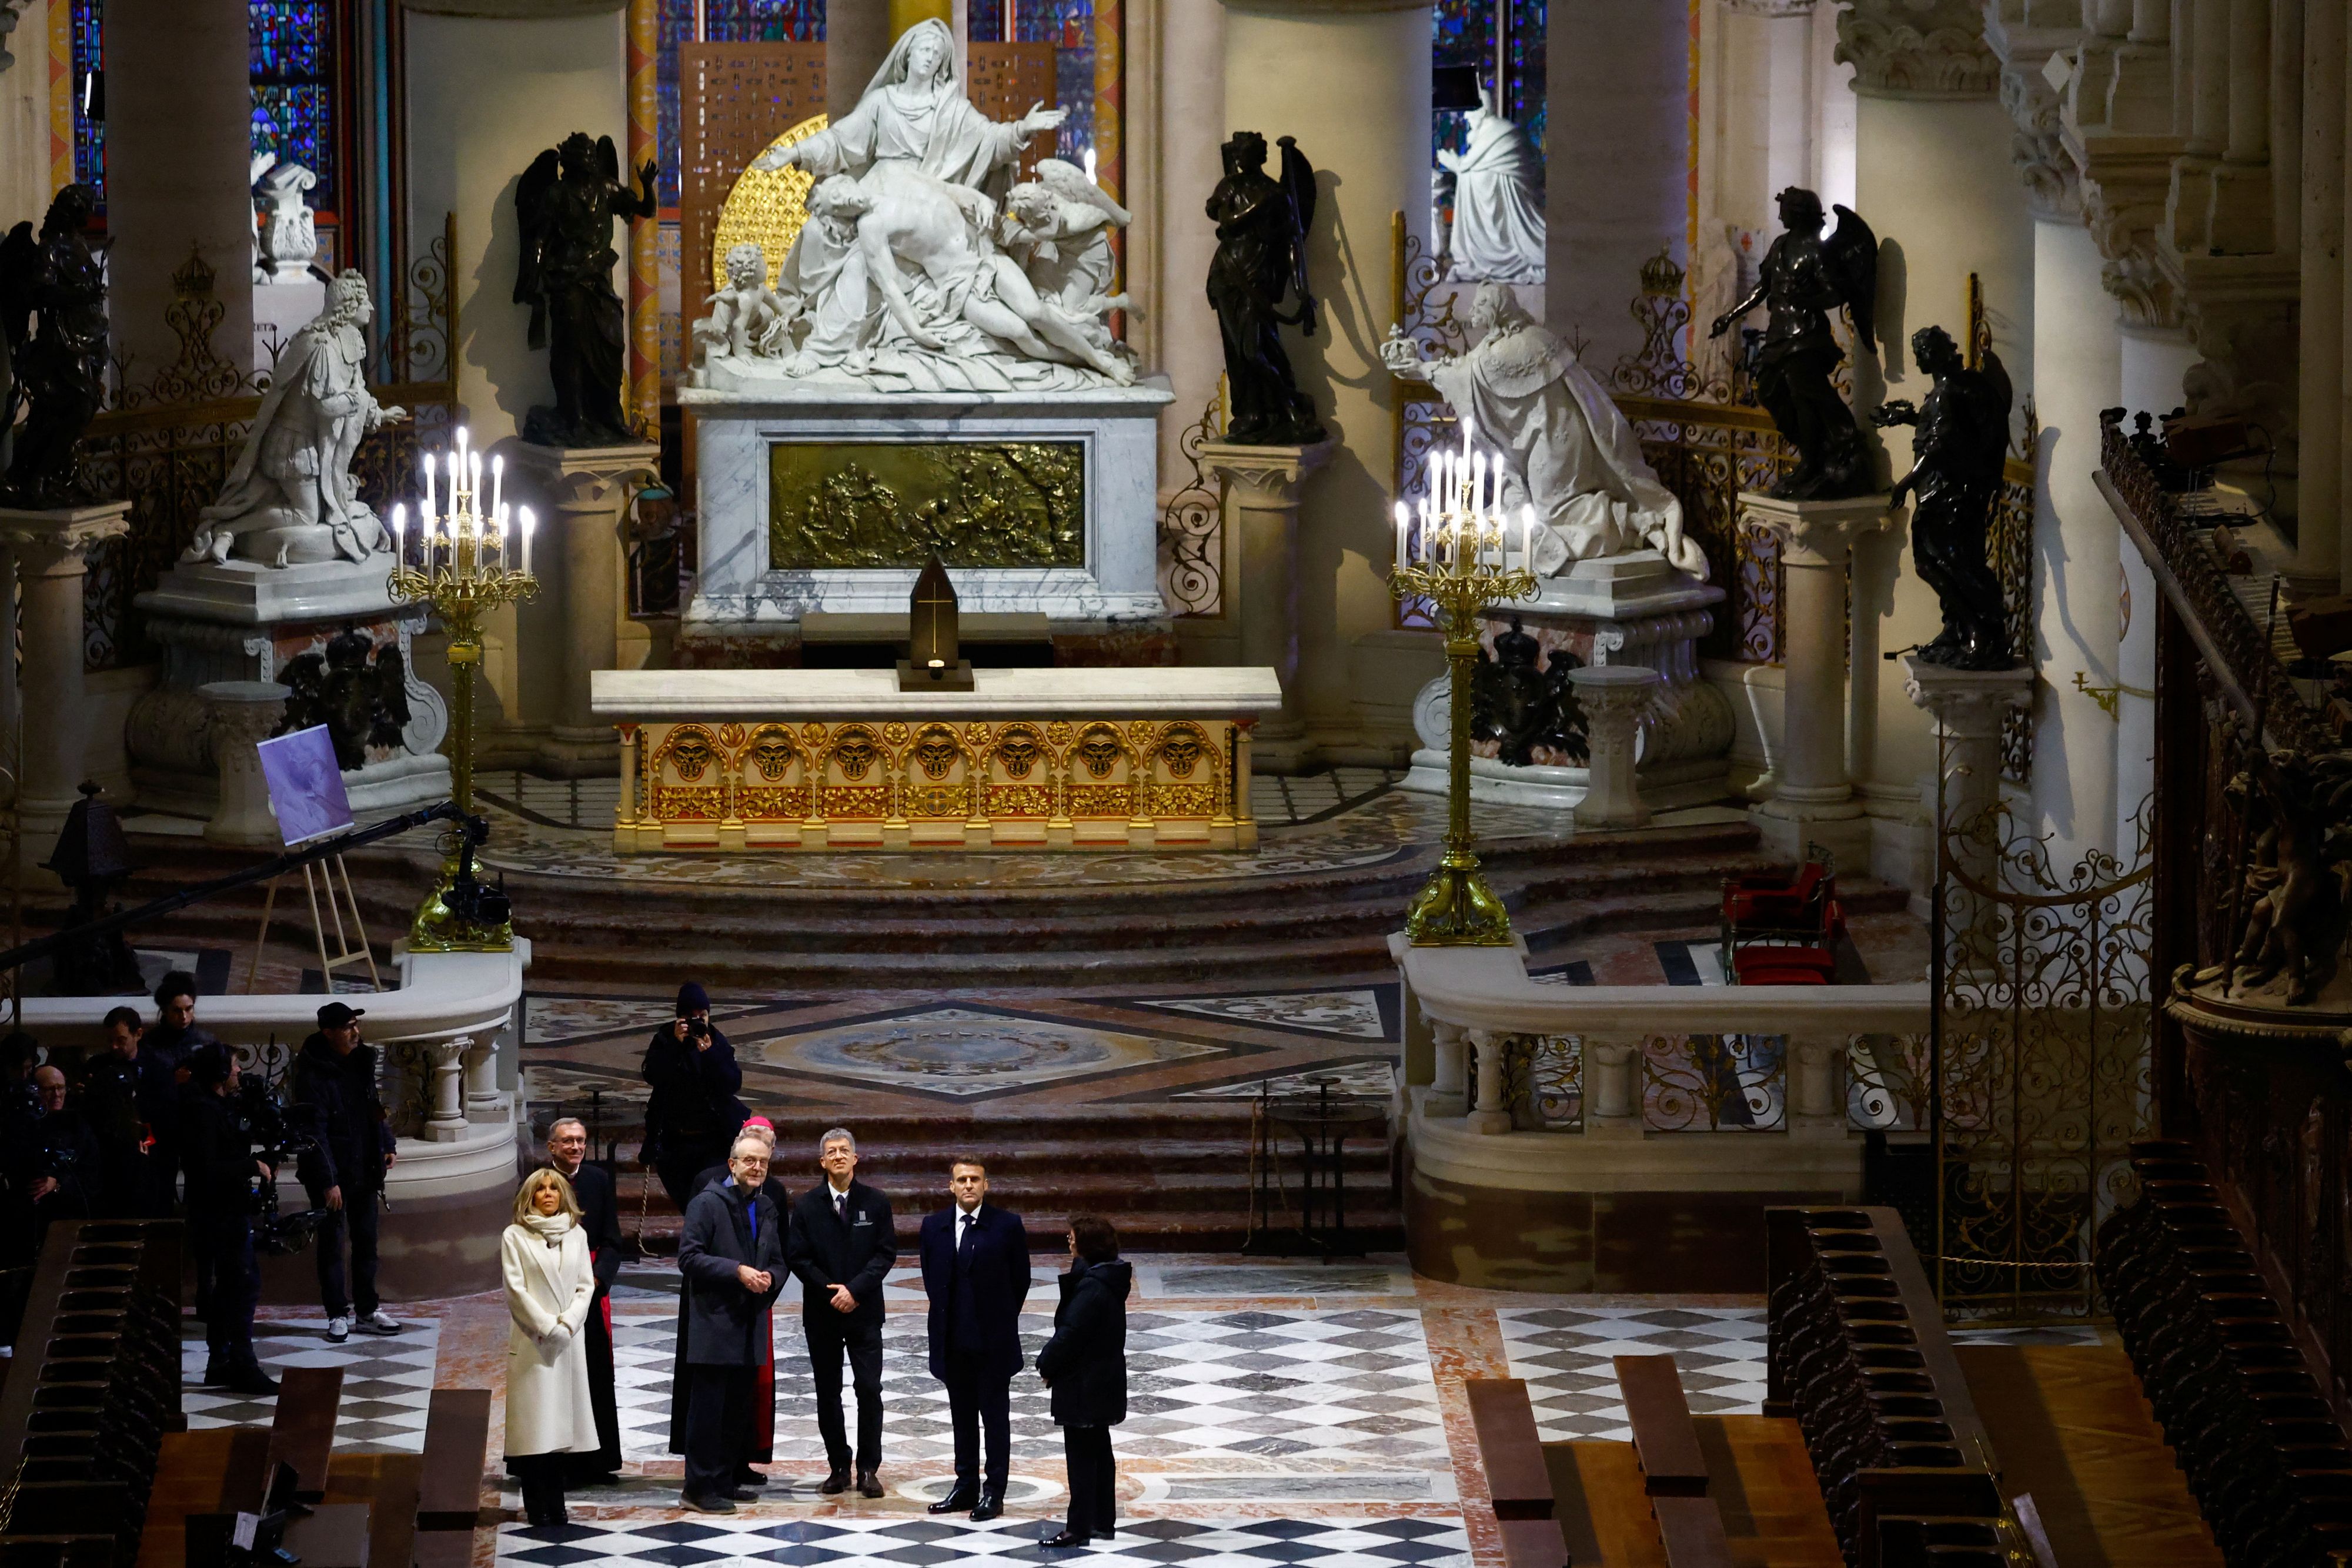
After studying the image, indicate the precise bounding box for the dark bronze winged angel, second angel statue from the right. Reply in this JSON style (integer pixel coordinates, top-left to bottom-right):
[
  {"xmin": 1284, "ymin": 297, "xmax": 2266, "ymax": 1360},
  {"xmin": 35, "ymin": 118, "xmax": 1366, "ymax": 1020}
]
[{"xmin": 1708, "ymin": 186, "xmax": 1879, "ymax": 501}]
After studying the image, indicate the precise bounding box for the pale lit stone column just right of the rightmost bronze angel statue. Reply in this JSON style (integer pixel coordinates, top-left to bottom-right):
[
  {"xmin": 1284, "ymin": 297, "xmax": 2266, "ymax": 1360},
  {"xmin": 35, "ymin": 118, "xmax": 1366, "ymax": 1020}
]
[{"xmin": 2018, "ymin": 219, "xmax": 2126, "ymax": 865}]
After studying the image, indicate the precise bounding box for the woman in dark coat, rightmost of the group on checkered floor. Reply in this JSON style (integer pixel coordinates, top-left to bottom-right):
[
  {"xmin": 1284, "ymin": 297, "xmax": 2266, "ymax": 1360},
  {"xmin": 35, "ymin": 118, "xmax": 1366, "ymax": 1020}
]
[{"xmin": 1037, "ymin": 1215, "xmax": 1136, "ymax": 1547}]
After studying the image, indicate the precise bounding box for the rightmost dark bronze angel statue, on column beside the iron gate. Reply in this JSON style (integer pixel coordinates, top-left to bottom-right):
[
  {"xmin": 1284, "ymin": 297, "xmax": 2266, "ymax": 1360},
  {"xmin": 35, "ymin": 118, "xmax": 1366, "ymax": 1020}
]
[{"xmin": 1870, "ymin": 327, "xmax": 2016, "ymax": 670}]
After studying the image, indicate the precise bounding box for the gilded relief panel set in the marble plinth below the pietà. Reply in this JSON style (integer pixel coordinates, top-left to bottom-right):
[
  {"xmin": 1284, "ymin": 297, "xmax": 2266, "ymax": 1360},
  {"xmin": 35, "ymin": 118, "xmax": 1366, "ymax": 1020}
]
[{"xmin": 767, "ymin": 442, "xmax": 1087, "ymax": 571}]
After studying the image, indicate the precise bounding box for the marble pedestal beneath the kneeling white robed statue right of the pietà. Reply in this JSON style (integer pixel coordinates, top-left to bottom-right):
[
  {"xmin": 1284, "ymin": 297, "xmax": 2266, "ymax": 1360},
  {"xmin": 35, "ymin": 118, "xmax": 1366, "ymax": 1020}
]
[{"xmin": 1404, "ymin": 550, "xmax": 1731, "ymax": 811}]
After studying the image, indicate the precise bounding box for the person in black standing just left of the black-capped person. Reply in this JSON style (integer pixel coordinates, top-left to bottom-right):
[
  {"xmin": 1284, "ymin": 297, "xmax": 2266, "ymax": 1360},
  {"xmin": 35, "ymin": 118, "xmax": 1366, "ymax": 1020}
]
[{"xmin": 181, "ymin": 1044, "xmax": 278, "ymax": 1396}]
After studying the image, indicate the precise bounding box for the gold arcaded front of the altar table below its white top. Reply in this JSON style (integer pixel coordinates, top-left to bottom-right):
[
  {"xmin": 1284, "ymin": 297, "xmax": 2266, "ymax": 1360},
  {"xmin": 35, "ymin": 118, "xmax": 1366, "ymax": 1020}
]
[{"xmin": 614, "ymin": 720, "xmax": 1258, "ymax": 851}]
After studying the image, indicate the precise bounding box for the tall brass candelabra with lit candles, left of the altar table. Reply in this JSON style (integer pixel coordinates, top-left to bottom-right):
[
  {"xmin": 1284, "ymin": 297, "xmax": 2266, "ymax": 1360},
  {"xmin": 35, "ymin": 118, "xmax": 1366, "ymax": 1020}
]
[{"xmin": 388, "ymin": 426, "xmax": 539, "ymax": 952}]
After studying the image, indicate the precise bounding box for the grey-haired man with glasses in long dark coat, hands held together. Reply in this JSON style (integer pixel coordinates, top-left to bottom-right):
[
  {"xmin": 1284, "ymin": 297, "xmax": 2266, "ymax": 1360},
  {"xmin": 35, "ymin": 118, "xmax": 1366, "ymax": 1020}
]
[{"xmin": 670, "ymin": 1138, "xmax": 783, "ymax": 1514}]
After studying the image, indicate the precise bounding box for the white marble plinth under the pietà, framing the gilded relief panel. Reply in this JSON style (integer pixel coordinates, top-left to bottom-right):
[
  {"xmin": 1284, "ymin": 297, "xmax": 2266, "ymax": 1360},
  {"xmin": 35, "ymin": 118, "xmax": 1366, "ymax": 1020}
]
[{"xmin": 680, "ymin": 376, "xmax": 1174, "ymax": 644}]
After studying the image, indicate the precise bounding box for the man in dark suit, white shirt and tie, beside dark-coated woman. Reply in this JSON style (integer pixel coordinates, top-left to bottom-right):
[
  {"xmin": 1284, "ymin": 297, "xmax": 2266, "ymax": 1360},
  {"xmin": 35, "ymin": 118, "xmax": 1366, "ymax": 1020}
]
[{"xmin": 917, "ymin": 1159, "xmax": 1028, "ymax": 1521}]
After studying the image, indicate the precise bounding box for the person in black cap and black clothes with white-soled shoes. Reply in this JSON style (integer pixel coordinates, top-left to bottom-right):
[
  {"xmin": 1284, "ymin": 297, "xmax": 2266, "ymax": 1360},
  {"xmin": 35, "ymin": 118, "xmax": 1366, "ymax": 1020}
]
[{"xmin": 294, "ymin": 1001, "xmax": 405, "ymax": 1345}]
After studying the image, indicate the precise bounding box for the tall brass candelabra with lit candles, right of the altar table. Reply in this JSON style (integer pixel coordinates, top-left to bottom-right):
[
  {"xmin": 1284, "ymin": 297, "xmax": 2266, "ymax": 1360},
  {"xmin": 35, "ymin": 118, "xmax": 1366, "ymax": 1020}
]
[{"xmin": 1388, "ymin": 433, "xmax": 1536, "ymax": 947}]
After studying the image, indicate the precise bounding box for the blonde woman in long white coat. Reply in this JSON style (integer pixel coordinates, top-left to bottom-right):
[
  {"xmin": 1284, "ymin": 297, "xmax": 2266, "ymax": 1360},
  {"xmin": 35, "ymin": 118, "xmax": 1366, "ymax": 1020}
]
[{"xmin": 499, "ymin": 1171, "xmax": 597, "ymax": 1526}]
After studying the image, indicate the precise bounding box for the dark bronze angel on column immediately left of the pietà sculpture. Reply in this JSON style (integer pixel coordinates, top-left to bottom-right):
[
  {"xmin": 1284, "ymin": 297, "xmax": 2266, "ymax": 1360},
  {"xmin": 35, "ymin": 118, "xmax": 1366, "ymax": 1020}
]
[{"xmin": 515, "ymin": 132, "xmax": 656, "ymax": 447}]
